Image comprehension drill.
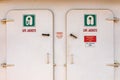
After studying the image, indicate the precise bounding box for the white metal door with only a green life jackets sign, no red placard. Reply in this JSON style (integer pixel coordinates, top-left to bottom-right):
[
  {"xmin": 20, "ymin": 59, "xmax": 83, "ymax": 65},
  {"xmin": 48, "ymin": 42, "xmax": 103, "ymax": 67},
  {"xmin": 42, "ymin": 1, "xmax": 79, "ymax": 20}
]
[{"xmin": 3, "ymin": 10, "xmax": 54, "ymax": 80}]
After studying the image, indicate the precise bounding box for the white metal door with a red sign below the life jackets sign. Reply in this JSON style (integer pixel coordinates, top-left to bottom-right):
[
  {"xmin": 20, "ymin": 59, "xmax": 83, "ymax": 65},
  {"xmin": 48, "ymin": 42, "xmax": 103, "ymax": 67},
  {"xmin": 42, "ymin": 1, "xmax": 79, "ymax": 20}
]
[{"xmin": 66, "ymin": 10, "xmax": 114, "ymax": 80}]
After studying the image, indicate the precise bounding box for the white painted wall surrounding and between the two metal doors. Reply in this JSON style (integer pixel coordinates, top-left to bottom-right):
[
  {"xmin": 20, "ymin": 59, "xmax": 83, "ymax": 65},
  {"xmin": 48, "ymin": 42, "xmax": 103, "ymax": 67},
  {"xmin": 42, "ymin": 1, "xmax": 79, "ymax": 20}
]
[{"xmin": 0, "ymin": 0, "xmax": 120, "ymax": 80}]
